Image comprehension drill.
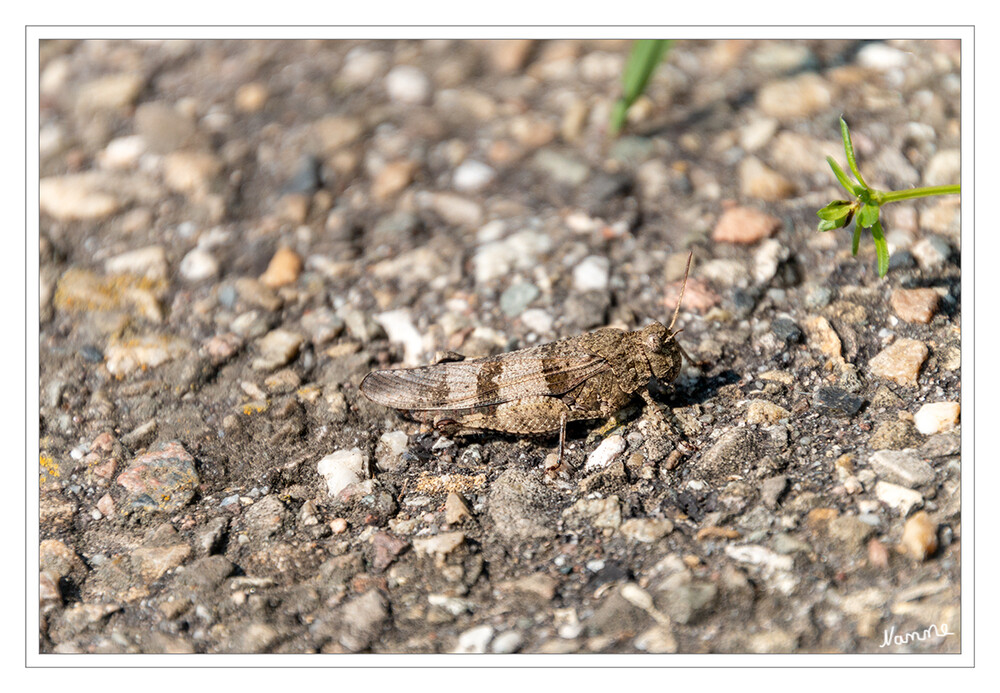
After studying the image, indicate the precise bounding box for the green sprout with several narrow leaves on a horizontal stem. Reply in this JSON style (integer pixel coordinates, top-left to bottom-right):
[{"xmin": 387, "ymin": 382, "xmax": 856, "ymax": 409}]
[{"xmin": 816, "ymin": 118, "xmax": 962, "ymax": 277}]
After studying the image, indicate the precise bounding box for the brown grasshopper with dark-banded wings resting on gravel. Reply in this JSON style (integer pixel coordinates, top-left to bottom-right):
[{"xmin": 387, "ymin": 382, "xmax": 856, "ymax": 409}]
[{"xmin": 361, "ymin": 255, "xmax": 691, "ymax": 460}]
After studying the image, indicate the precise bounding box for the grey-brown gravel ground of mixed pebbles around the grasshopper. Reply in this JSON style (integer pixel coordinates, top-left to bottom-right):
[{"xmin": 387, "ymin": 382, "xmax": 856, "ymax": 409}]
[{"xmin": 39, "ymin": 41, "xmax": 962, "ymax": 653}]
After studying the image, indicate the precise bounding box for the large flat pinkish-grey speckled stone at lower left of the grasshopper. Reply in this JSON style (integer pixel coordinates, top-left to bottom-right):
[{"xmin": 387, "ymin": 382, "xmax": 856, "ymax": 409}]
[{"xmin": 117, "ymin": 441, "xmax": 199, "ymax": 512}]
